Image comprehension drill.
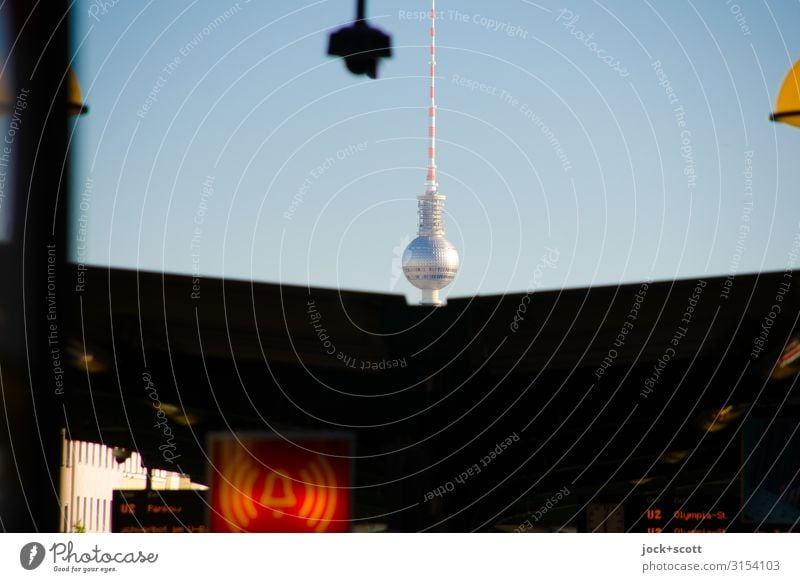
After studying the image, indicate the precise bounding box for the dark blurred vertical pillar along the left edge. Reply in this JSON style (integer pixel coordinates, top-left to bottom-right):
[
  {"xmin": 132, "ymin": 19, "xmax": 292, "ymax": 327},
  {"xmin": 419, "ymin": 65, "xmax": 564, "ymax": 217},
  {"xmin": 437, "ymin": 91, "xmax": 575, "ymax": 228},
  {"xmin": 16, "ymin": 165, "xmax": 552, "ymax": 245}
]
[{"xmin": 0, "ymin": 0, "xmax": 69, "ymax": 532}]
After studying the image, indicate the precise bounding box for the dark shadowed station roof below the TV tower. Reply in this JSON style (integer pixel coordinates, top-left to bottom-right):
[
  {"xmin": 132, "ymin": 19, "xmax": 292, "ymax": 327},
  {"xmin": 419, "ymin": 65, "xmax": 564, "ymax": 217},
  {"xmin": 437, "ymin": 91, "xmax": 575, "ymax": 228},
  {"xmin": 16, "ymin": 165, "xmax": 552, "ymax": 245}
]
[{"xmin": 67, "ymin": 268, "xmax": 800, "ymax": 531}]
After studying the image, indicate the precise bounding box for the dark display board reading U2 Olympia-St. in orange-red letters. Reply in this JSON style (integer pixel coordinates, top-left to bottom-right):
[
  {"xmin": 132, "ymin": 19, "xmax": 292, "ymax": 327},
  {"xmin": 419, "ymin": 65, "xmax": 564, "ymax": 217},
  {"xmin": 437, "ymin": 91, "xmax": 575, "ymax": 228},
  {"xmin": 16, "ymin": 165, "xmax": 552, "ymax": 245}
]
[{"xmin": 626, "ymin": 497, "xmax": 735, "ymax": 533}]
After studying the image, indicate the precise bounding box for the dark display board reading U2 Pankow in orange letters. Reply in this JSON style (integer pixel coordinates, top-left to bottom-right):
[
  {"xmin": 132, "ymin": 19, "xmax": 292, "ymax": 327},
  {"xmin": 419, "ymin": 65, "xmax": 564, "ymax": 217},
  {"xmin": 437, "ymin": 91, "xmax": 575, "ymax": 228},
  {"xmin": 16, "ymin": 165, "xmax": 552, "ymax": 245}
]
[{"xmin": 111, "ymin": 489, "xmax": 208, "ymax": 533}]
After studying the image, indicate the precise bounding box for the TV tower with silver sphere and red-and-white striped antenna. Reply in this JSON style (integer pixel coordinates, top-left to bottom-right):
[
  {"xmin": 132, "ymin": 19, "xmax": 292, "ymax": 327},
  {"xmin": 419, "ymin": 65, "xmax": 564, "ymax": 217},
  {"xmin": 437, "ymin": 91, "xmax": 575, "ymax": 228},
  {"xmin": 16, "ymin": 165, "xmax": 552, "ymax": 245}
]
[{"xmin": 403, "ymin": 0, "xmax": 460, "ymax": 307}]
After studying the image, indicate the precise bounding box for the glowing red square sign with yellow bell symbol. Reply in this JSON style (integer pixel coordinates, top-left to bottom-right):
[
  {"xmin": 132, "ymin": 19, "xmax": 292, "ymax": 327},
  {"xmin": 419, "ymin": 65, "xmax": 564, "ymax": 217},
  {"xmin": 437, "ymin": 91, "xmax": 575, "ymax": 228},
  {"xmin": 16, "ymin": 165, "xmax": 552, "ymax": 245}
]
[{"xmin": 209, "ymin": 434, "xmax": 352, "ymax": 533}]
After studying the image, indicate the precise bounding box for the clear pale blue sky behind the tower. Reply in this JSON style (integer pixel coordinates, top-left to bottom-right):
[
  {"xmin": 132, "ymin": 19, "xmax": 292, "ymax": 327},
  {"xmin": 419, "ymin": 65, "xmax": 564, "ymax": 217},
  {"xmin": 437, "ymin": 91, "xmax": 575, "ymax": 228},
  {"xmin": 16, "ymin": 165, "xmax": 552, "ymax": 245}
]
[{"xmin": 74, "ymin": 0, "xmax": 800, "ymax": 300}]
